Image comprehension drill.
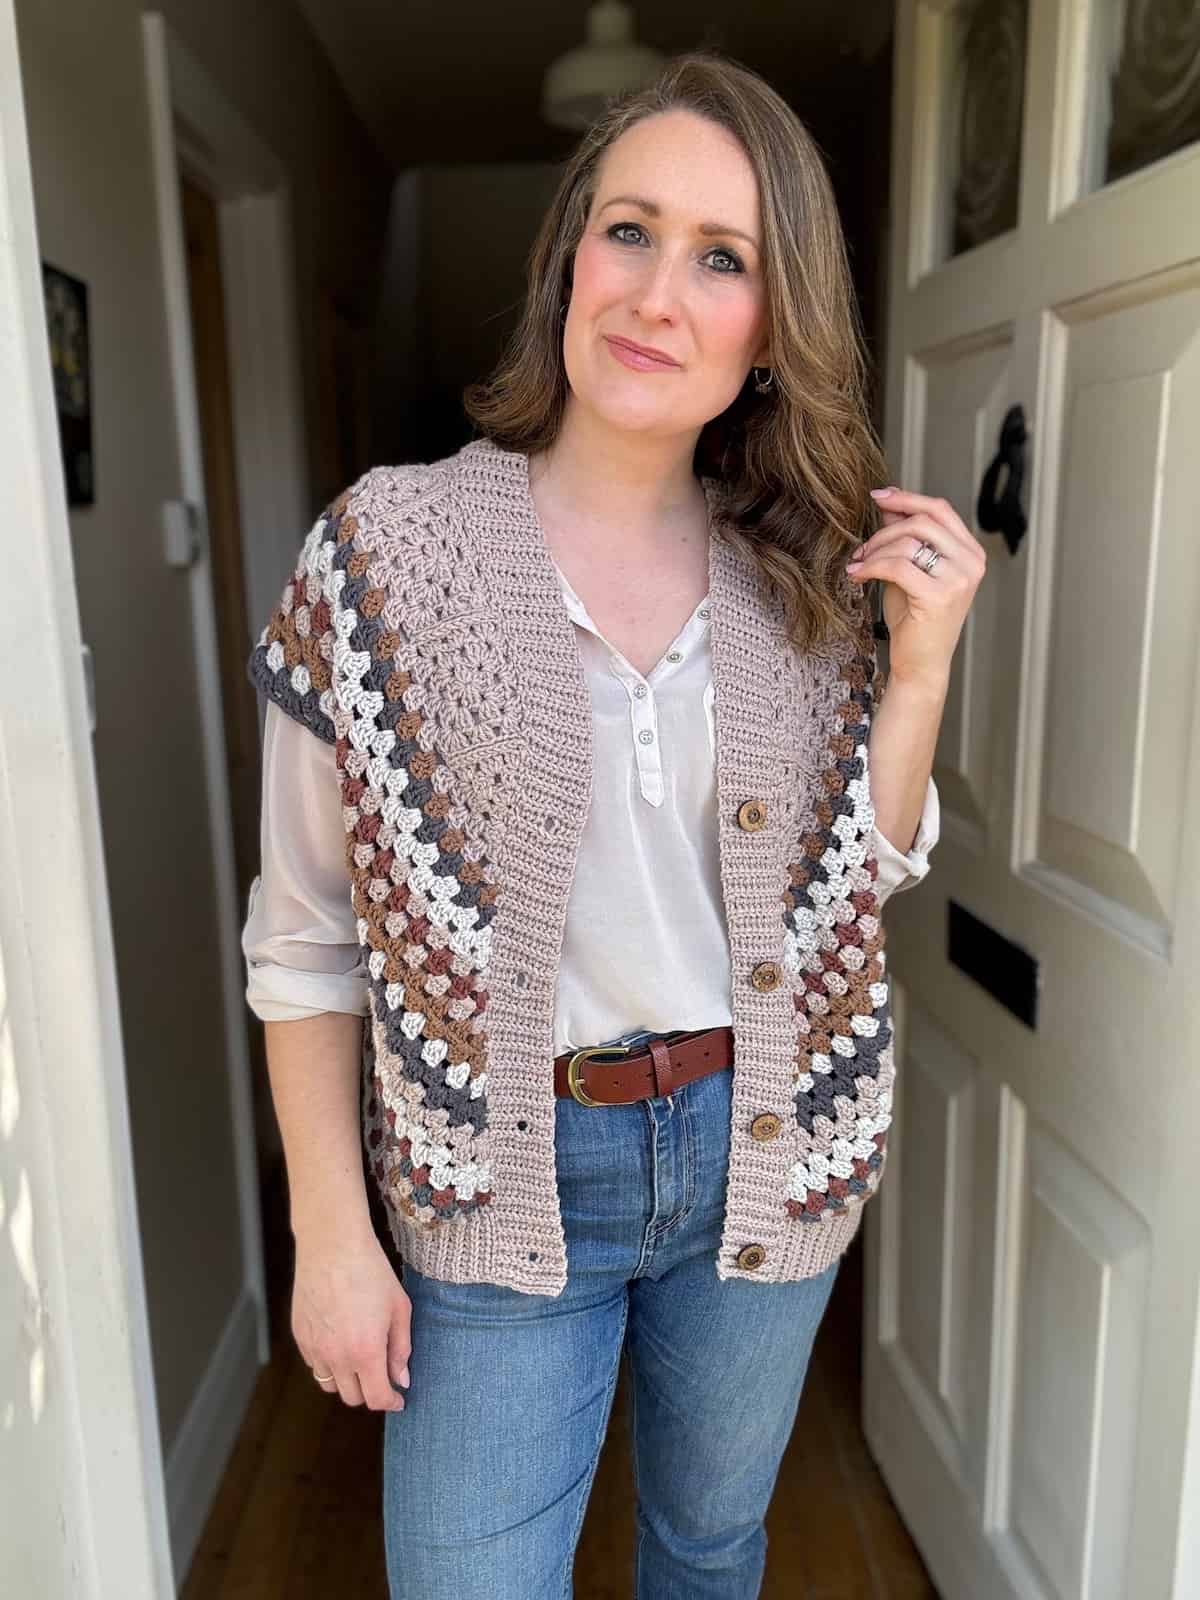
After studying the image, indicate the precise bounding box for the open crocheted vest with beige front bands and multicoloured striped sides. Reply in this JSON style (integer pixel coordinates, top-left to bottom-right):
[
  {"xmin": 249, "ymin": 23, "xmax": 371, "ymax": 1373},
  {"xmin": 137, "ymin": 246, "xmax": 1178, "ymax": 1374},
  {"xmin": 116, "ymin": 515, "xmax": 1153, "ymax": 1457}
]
[{"xmin": 250, "ymin": 440, "xmax": 893, "ymax": 1294}]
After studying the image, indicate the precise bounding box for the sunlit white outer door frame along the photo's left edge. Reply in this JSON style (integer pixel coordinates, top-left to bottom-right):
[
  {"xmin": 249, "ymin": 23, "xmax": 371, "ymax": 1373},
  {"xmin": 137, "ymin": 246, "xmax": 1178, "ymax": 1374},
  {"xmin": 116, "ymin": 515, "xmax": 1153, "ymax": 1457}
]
[{"xmin": 0, "ymin": 0, "xmax": 174, "ymax": 1600}]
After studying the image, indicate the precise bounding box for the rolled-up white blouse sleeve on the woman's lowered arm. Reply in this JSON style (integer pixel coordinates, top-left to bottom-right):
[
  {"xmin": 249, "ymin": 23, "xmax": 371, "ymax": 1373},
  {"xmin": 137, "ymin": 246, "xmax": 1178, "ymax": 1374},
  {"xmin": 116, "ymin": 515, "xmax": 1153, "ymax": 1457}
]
[{"xmin": 242, "ymin": 702, "xmax": 368, "ymax": 1022}]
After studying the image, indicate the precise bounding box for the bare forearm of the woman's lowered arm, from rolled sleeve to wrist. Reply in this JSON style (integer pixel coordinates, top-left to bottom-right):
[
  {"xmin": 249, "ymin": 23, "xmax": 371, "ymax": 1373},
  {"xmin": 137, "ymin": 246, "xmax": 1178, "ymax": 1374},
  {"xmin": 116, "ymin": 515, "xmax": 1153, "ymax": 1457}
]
[{"xmin": 264, "ymin": 1011, "xmax": 371, "ymax": 1242}]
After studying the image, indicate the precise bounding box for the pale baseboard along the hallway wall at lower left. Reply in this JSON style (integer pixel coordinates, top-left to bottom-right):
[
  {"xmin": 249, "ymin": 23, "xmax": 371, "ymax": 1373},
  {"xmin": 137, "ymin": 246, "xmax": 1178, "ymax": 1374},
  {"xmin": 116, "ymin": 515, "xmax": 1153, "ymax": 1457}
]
[{"xmin": 165, "ymin": 1288, "xmax": 259, "ymax": 1589}]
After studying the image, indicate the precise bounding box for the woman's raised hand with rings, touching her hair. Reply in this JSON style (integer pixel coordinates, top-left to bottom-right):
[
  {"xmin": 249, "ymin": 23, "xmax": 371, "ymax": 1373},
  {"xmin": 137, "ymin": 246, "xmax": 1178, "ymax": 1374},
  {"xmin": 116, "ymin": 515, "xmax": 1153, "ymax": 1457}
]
[{"xmin": 846, "ymin": 488, "xmax": 987, "ymax": 688}]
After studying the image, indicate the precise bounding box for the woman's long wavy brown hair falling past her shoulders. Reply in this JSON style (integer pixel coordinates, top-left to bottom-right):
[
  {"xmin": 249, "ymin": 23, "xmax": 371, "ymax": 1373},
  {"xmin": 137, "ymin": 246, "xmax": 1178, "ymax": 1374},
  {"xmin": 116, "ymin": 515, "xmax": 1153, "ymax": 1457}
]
[{"xmin": 462, "ymin": 51, "xmax": 888, "ymax": 648}]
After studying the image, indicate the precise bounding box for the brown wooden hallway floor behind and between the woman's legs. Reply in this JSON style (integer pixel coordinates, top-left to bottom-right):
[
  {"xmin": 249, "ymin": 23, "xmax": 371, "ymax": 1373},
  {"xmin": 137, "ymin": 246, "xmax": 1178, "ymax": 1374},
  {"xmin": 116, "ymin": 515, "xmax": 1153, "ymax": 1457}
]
[{"xmin": 181, "ymin": 1177, "xmax": 938, "ymax": 1600}]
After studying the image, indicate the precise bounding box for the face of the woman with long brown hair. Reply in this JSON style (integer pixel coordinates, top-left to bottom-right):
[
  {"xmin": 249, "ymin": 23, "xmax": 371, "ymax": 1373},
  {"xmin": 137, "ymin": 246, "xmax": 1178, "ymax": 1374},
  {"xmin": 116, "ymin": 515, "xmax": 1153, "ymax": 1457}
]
[{"xmin": 563, "ymin": 110, "xmax": 768, "ymax": 435}]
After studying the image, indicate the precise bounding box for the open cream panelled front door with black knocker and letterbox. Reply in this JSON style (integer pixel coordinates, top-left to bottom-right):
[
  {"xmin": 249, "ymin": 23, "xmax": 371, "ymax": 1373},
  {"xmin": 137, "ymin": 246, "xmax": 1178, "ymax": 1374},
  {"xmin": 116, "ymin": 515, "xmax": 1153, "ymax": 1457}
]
[{"xmin": 864, "ymin": 0, "xmax": 1200, "ymax": 1600}]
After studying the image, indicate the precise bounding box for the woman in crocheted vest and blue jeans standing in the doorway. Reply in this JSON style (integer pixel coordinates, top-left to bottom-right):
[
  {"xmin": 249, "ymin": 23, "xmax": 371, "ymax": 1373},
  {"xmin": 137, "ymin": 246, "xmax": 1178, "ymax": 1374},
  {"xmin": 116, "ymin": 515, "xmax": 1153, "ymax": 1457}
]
[{"xmin": 245, "ymin": 54, "xmax": 984, "ymax": 1600}]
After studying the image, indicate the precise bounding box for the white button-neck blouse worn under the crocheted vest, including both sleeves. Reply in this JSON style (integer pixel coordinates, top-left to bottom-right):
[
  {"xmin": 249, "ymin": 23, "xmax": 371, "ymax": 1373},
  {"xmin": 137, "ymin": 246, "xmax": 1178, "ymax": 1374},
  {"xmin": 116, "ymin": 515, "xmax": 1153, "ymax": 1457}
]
[{"xmin": 242, "ymin": 568, "xmax": 939, "ymax": 1054}]
